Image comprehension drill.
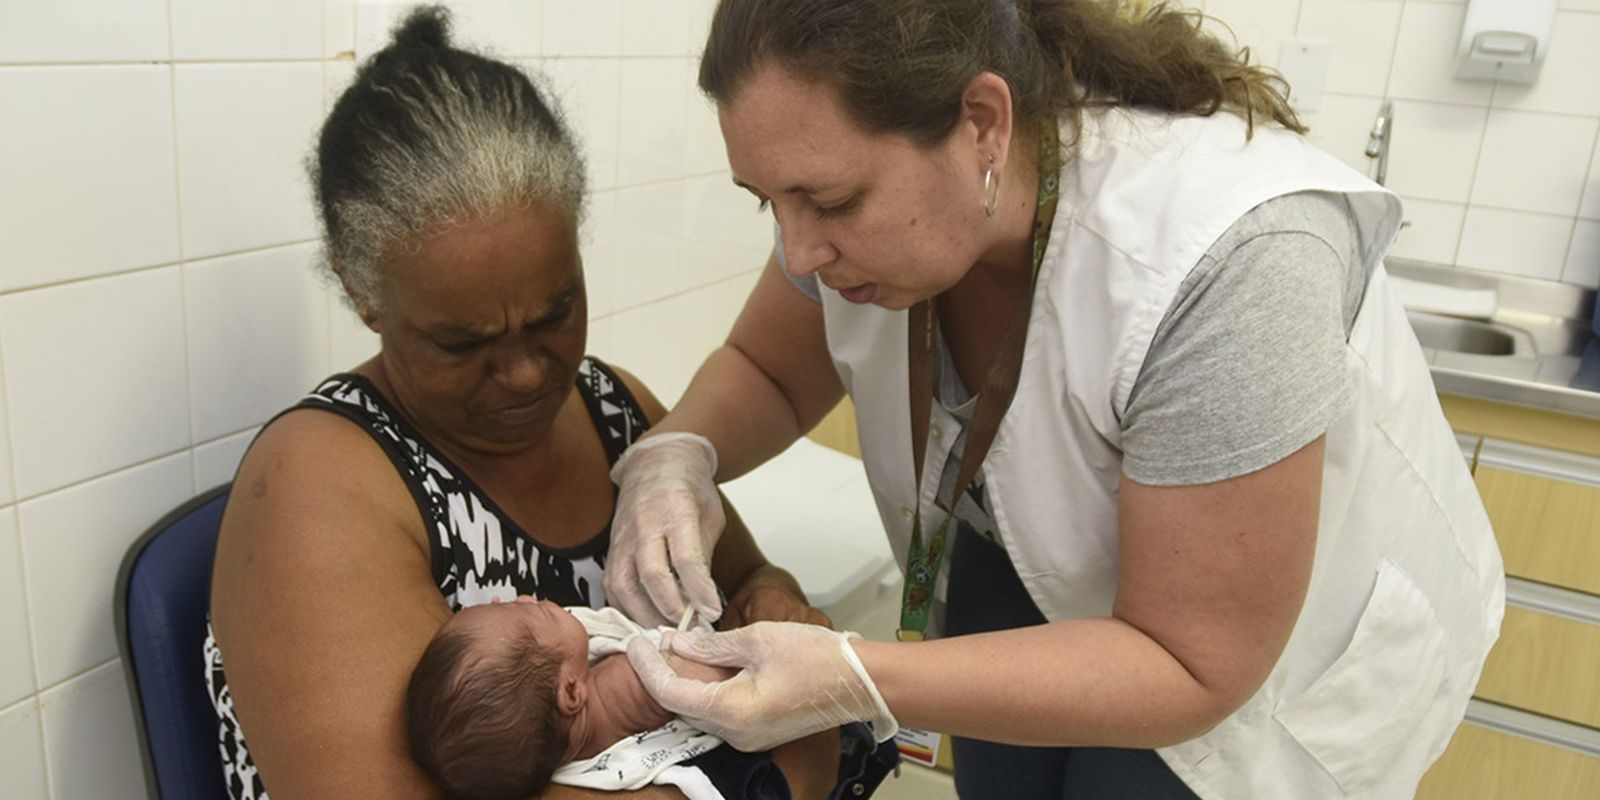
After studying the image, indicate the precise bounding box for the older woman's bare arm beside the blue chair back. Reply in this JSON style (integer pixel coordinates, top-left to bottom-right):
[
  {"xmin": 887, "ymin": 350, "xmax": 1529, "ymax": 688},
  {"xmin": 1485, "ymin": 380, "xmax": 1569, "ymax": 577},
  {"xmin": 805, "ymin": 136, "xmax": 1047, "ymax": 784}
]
[{"xmin": 211, "ymin": 411, "xmax": 697, "ymax": 800}]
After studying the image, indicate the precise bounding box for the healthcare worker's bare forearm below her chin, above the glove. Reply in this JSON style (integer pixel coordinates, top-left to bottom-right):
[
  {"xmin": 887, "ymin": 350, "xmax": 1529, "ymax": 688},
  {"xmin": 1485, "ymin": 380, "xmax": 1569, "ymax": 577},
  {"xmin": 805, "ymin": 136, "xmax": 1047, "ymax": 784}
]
[{"xmin": 653, "ymin": 256, "xmax": 845, "ymax": 482}]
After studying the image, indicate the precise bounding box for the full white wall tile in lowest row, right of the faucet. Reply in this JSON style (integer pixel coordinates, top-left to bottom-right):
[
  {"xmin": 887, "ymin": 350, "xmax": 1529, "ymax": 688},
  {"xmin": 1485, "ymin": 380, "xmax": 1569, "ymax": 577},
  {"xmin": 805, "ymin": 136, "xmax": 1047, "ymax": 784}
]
[{"xmin": 1456, "ymin": 206, "xmax": 1573, "ymax": 280}]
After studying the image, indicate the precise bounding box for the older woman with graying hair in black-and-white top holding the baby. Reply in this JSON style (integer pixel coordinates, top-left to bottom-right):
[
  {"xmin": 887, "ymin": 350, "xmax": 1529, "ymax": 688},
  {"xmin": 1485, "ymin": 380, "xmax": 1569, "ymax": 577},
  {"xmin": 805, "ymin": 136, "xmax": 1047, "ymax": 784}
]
[{"xmin": 206, "ymin": 10, "xmax": 837, "ymax": 800}]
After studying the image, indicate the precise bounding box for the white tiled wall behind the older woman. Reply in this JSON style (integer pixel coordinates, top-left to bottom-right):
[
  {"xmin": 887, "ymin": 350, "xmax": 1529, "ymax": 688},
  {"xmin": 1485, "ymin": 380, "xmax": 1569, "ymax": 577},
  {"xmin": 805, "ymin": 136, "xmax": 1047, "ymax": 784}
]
[{"xmin": 0, "ymin": 0, "xmax": 771, "ymax": 800}]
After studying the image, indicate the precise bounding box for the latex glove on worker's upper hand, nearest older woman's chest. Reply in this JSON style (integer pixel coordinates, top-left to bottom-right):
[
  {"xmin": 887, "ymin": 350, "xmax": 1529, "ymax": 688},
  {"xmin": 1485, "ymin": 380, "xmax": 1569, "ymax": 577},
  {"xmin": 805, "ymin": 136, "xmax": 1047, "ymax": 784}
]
[{"xmin": 605, "ymin": 434, "xmax": 726, "ymax": 627}]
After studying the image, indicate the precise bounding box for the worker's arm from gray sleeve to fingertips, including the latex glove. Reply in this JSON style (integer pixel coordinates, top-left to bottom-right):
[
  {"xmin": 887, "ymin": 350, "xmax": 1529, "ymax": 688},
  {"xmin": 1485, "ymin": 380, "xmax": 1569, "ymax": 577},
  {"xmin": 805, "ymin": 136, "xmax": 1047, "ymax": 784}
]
[{"xmin": 627, "ymin": 437, "xmax": 1323, "ymax": 749}]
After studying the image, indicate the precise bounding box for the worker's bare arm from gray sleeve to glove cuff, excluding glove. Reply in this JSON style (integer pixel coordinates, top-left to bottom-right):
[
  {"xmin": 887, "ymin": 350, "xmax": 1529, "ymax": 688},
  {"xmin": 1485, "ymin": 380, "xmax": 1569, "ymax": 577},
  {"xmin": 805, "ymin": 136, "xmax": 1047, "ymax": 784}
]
[{"xmin": 856, "ymin": 437, "xmax": 1323, "ymax": 747}]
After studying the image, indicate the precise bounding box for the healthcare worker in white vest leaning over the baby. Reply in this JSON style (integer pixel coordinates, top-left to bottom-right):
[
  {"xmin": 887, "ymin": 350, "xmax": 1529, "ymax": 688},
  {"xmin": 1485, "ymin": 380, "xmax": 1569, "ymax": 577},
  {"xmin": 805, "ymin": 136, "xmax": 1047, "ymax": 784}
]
[{"xmin": 606, "ymin": 0, "xmax": 1504, "ymax": 800}]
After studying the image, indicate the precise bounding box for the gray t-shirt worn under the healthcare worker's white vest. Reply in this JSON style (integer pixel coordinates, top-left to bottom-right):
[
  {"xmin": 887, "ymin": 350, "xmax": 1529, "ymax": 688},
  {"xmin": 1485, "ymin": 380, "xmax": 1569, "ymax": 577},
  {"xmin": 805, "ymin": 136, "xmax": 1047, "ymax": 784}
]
[{"xmin": 778, "ymin": 192, "xmax": 1366, "ymax": 499}]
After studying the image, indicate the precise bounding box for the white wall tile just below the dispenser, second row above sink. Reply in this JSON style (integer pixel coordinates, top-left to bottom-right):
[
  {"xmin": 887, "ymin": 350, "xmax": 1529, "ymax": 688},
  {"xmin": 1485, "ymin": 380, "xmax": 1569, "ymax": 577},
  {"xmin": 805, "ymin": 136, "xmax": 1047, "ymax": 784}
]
[{"xmin": 1472, "ymin": 109, "xmax": 1600, "ymax": 216}]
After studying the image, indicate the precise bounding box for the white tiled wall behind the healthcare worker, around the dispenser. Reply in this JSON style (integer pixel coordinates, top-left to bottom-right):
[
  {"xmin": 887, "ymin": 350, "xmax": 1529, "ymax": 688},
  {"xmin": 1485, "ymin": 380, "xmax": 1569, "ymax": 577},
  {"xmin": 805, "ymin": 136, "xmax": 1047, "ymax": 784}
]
[{"xmin": 1184, "ymin": 0, "xmax": 1600, "ymax": 286}]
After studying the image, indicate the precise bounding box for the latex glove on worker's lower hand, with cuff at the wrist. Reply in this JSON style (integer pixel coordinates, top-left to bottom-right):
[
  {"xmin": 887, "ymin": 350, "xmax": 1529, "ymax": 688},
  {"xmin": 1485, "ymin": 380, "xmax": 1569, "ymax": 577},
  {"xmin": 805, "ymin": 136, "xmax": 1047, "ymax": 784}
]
[{"xmin": 627, "ymin": 622, "xmax": 899, "ymax": 752}]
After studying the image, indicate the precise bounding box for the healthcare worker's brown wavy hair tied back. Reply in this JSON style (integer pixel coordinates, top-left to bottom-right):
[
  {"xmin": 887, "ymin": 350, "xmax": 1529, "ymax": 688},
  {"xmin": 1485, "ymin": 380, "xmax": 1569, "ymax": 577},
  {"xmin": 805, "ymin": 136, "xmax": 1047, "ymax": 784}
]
[{"xmin": 699, "ymin": 0, "xmax": 1306, "ymax": 146}]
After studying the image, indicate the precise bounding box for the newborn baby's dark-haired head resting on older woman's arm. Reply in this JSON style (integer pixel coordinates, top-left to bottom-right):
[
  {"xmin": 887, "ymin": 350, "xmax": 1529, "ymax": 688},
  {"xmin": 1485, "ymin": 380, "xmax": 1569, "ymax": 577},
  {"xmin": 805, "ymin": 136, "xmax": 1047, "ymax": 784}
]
[{"xmin": 406, "ymin": 597, "xmax": 589, "ymax": 800}]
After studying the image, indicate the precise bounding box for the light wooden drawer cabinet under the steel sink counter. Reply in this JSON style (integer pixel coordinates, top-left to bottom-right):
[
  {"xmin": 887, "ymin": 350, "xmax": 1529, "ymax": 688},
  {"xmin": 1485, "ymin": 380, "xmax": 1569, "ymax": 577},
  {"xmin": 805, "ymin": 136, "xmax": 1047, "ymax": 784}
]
[{"xmin": 1418, "ymin": 395, "xmax": 1600, "ymax": 800}]
